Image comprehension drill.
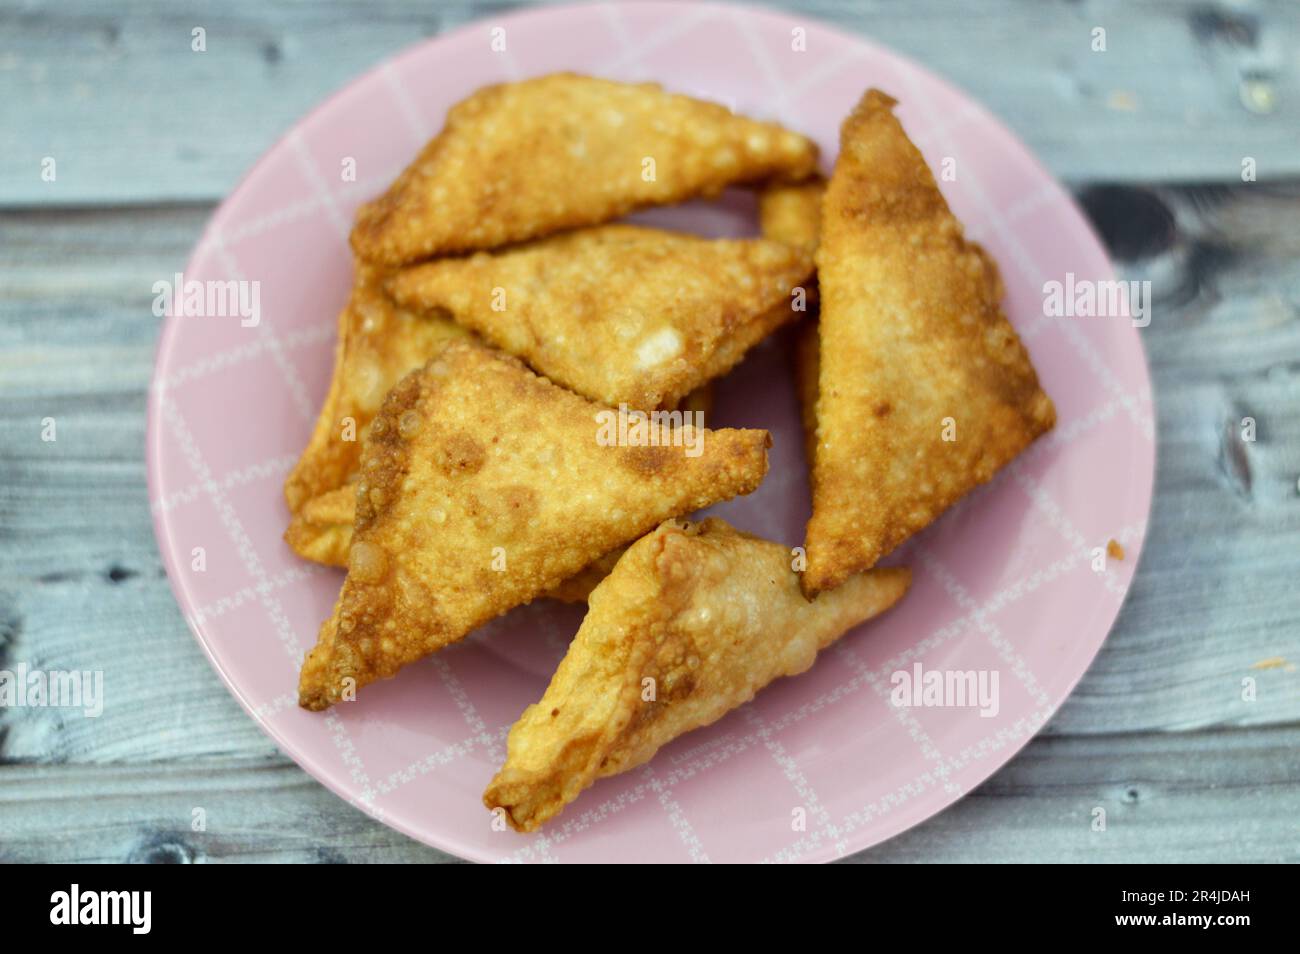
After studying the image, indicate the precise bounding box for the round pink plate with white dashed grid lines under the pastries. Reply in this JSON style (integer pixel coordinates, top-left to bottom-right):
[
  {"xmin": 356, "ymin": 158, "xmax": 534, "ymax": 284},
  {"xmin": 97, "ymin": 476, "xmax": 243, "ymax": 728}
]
[{"xmin": 148, "ymin": 3, "xmax": 1154, "ymax": 862}]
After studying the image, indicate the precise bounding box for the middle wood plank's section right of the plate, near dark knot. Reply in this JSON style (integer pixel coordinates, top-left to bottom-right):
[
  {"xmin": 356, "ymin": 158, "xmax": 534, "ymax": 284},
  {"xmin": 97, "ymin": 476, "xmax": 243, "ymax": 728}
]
[{"xmin": 1048, "ymin": 186, "xmax": 1300, "ymax": 732}]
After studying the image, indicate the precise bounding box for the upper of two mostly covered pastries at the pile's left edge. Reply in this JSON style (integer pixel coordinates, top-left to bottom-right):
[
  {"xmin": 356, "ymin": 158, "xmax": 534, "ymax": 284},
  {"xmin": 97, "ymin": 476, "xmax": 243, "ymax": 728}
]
[{"xmin": 285, "ymin": 263, "xmax": 469, "ymax": 514}]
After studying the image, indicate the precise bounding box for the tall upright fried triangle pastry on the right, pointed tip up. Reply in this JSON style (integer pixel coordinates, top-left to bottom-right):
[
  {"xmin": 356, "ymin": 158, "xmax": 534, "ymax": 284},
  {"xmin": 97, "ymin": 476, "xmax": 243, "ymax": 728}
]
[{"xmin": 803, "ymin": 90, "xmax": 1056, "ymax": 595}]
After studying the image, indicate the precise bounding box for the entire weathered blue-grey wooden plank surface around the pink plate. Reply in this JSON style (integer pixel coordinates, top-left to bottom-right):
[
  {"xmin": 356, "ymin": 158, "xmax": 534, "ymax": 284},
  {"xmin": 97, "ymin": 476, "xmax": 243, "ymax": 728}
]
[{"xmin": 0, "ymin": 0, "xmax": 1300, "ymax": 862}]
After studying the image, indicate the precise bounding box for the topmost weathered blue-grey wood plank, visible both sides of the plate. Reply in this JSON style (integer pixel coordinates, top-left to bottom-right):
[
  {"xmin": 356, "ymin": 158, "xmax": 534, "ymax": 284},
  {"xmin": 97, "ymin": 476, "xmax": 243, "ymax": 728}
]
[{"xmin": 0, "ymin": 0, "xmax": 1300, "ymax": 207}]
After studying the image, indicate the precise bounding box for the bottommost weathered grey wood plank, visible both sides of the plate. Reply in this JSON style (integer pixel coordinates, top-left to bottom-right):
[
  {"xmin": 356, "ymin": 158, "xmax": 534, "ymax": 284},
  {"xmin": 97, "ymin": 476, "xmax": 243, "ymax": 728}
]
[{"xmin": 0, "ymin": 727, "xmax": 1300, "ymax": 863}]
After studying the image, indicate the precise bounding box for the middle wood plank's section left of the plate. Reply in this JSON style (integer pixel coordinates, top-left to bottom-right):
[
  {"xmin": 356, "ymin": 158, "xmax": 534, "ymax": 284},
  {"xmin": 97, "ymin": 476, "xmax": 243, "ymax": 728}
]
[{"xmin": 0, "ymin": 207, "xmax": 276, "ymax": 762}]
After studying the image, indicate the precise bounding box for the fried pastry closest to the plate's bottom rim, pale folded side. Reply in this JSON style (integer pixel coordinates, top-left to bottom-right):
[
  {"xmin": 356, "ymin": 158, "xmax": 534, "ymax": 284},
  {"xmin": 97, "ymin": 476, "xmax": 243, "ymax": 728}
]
[{"xmin": 484, "ymin": 519, "xmax": 910, "ymax": 832}]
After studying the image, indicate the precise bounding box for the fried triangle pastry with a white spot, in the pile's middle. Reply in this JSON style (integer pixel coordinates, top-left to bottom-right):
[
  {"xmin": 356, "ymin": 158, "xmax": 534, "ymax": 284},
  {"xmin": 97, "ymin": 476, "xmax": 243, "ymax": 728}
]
[{"xmin": 387, "ymin": 225, "xmax": 813, "ymax": 411}]
